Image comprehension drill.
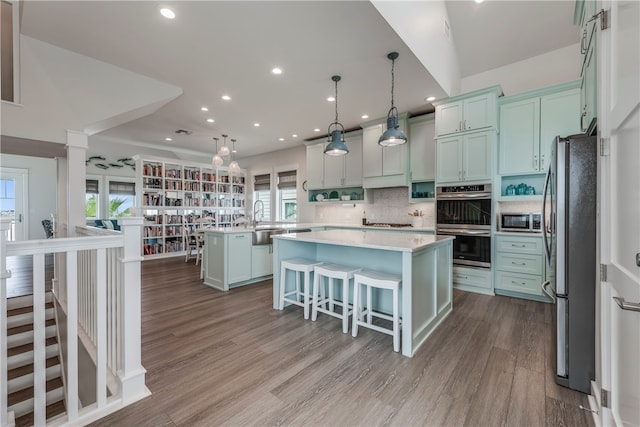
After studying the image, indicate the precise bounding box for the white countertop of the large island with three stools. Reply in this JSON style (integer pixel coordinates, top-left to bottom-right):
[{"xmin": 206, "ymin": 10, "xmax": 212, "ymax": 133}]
[{"xmin": 273, "ymin": 228, "xmax": 454, "ymax": 252}]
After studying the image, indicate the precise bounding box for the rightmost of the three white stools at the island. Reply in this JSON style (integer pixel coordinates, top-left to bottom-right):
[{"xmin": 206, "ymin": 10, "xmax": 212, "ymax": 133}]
[{"xmin": 351, "ymin": 270, "xmax": 402, "ymax": 352}]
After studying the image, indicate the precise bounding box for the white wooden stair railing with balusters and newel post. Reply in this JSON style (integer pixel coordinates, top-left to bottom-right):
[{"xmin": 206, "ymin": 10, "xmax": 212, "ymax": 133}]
[{"xmin": 0, "ymin": 218, "xmax": 150, "ymax": 426}]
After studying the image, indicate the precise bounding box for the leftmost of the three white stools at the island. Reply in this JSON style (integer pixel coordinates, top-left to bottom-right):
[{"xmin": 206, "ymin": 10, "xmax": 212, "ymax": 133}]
[{"xmin": 278, "ymin": 258, "xmax": 322, "ymax": 319}]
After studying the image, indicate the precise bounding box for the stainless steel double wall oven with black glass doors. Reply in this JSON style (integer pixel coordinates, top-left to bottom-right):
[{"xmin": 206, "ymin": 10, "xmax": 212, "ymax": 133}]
[{"xmin": 436, "ymin": 184, "xmax": 493, "ymax": 268}]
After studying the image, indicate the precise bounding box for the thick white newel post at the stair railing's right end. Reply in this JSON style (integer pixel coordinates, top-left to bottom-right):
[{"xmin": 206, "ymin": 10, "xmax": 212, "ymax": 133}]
[{"xmin": 118, "ymin": 217, "xmax": 151, "ymax": 404}]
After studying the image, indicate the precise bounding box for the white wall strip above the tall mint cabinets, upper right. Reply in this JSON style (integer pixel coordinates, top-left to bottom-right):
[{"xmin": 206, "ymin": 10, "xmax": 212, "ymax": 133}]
[{"xmin": 461, "ymin": 44, "xmax": 582, "ymax": 95}]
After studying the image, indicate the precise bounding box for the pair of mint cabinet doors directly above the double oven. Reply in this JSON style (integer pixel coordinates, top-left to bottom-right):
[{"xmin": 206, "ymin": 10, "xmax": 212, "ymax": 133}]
[{"xmin": 436, "ymin": 131, "xmax": 495, "ymax": 182}]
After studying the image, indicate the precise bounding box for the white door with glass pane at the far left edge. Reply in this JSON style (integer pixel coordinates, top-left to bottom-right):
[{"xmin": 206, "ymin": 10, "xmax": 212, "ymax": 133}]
[{"xmin": 0, "ymin": 168, "xmax": 29, "ymax": 241}]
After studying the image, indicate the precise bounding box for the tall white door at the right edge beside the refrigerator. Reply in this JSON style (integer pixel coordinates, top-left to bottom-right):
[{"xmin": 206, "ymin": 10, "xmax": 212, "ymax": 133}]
[{"xmin": 597, "ymin": 0, "xmax": 640, "ymax": 426}]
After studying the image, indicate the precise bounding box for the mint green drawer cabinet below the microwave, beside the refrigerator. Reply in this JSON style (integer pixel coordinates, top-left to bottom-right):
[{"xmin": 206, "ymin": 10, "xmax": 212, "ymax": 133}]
[{"xmin": 494, "ymin": 235, "xmax": 548, "ymax": 302}]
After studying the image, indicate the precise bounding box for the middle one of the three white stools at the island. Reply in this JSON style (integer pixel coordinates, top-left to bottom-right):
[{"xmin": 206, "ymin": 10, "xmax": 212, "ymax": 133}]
[{"xmin": 311, "ymin": 264, "xmax": 360, "ymax": 334}]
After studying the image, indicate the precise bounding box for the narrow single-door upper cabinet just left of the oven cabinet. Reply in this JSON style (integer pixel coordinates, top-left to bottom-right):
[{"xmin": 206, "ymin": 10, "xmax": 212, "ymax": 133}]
[{"xmin": 409, "ymin": 116, "xmax": 436, "ymax": 181}]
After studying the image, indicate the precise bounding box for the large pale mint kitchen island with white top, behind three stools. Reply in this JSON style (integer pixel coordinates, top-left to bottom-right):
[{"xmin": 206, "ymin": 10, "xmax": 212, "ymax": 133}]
[{"xmin": 273, "ymin": 230, "xmax": 453, "ymax": 357}]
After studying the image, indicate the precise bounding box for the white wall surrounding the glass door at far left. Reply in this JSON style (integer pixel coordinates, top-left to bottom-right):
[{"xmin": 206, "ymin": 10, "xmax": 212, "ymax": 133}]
[{"xmin": 0, "ymin": 154, "xmax": 58, "ymax": 239}]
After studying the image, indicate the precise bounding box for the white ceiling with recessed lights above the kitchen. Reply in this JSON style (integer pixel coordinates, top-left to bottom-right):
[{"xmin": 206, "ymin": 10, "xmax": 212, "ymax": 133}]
[{"xmin": 21, "ymin": 0, "xmax": 578, "ymax": 158}]
